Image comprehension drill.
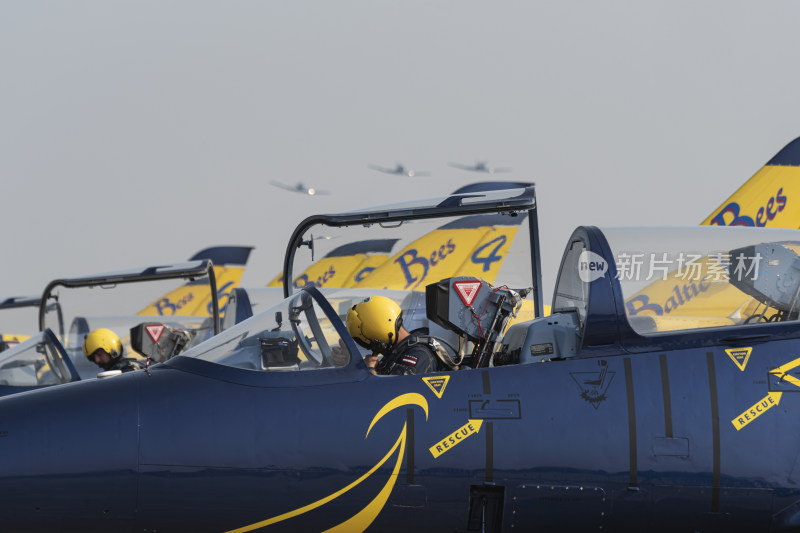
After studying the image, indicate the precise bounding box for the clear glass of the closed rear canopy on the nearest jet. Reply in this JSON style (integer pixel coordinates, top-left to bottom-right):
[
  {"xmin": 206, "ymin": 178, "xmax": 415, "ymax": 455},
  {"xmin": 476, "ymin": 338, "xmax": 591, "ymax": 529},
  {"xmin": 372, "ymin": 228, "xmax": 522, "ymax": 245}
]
[{"xmin": 602, "ymin": 227, "xmax": 800, "ymax": 334}]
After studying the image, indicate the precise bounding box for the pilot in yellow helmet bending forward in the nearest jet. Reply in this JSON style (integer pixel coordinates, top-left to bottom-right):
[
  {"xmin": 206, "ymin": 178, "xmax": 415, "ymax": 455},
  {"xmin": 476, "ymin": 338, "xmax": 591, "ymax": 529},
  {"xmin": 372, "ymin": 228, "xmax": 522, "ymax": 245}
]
[{"xmin": 346, "ymin": 296, "xmax": 453, "ymax": 375}]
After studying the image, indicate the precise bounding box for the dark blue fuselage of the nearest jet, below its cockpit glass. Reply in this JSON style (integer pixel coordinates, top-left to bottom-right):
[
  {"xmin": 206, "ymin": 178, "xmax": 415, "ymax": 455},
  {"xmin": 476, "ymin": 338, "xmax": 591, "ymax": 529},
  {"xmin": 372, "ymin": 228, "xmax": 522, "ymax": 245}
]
[{"xmin": 0, "ymin": 332, "xmax": 800, "ymax": 532}]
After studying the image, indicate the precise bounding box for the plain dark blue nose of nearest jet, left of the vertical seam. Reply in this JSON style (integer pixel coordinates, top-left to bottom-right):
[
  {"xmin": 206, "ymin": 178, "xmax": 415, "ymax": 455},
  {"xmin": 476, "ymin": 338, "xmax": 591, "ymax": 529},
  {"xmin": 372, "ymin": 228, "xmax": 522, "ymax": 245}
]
[{"xmin": 0, "ymin": 373, "xmax": 138, "ymax": 531}]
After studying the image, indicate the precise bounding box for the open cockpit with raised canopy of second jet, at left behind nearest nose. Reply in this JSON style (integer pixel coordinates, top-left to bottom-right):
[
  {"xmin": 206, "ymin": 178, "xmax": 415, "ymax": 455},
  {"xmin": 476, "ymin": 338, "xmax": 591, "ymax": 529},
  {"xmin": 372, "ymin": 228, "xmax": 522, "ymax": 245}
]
[{"xmin": 37, "ymin": 259, "xmax": 220, "ymax": 379}]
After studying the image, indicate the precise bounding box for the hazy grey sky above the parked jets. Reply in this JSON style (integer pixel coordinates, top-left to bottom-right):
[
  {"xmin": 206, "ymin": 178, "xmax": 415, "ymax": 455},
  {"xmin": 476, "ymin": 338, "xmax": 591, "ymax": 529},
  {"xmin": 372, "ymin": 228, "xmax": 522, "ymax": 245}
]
[{"xmin": 0, "ymin": 0, "xmax": 800, "ymax": 301}]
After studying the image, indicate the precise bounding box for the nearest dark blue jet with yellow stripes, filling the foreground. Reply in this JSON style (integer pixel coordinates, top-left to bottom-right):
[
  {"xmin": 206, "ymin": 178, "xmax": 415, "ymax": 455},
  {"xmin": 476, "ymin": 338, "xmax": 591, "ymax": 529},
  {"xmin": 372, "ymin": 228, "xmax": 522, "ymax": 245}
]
[{"xmin": 7, "ymin": 164, "xmax": 800, "ymax": 532}]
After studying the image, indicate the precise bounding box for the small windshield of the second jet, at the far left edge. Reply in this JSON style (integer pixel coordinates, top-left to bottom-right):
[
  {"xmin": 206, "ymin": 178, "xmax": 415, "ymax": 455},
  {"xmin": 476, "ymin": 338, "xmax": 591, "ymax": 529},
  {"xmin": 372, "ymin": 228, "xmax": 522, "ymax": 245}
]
[{"xmin": 0, "ymin": 330, "xmax": 77, "ymax": 387}]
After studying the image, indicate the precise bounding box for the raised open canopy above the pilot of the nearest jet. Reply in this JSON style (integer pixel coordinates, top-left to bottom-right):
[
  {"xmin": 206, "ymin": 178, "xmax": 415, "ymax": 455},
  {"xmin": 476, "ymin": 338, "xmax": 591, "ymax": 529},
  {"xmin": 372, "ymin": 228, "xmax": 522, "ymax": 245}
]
[{"xmin": 278, "ymin": 186, "xmax": 541, "ymax": 316}]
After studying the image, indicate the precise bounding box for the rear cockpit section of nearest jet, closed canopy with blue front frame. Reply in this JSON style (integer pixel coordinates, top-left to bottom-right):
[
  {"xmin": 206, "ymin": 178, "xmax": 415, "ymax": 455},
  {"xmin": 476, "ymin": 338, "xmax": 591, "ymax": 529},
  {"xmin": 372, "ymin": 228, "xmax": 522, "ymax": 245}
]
[{"xmin": 499, "ymin": 226, "xmax": 800, "ymax": 363}]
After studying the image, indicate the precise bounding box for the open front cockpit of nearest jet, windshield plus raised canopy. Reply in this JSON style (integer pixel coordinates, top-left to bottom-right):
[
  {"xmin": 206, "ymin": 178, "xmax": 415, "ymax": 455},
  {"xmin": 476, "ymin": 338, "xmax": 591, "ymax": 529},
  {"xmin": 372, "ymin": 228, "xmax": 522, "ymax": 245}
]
[{"xmin": 174, "ymin": 184, "xmax": 541, "ymax": 374}]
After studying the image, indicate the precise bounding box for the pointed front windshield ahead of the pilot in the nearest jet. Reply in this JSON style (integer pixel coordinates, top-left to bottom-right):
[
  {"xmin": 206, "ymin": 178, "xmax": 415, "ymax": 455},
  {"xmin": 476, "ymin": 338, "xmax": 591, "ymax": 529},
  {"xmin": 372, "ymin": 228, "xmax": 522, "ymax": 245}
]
[{"xmin": 184, "ymin": 290, "xmax": 352, "ymax": 372}]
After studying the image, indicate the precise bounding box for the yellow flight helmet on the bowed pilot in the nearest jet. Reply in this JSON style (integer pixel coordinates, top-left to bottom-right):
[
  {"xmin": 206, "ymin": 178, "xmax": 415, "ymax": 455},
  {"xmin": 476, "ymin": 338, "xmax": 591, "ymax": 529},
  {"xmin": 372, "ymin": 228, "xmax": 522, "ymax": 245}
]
[{"xmin": 346, "ymin": 296, "xmax": 403, "ymax": 355}]
